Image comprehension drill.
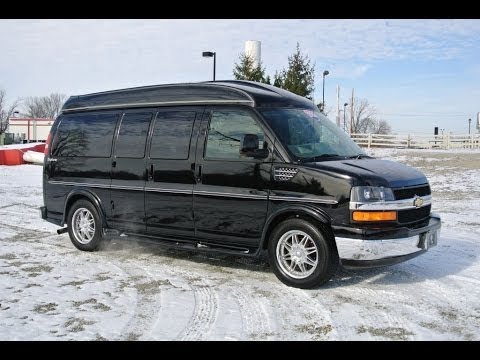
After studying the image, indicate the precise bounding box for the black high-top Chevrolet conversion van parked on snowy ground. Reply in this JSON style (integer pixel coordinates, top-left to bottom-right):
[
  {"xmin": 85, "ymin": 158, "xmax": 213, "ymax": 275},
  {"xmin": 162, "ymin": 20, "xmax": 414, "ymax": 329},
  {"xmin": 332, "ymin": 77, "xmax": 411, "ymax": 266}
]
[{"xmin": 41, "ymin": 81, "xmax": 441, "ymax": 288}]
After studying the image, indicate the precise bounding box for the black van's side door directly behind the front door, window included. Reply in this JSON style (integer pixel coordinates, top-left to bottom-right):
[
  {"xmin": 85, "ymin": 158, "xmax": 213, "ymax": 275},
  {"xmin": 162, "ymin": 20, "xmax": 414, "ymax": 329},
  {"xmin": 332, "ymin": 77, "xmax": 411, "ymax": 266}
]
[{"xmin": 145, "ymin": 107, "xmax": 204, "ymax": 239}]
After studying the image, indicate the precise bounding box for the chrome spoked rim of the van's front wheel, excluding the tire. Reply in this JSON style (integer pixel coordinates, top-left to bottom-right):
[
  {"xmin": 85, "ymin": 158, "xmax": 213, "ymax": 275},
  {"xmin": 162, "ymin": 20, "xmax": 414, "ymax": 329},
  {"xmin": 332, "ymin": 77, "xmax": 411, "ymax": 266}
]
[{"xmin": 276, "ymin": 230, "xmax": 318, "ymax": 279}]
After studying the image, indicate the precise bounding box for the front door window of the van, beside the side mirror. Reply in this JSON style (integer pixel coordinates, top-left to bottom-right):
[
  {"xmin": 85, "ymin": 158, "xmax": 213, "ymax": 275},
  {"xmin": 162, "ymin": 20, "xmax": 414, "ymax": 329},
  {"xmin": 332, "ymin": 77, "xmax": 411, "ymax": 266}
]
[{"xmin": 205, "ymin": 110, "xmax": 265, "ymax": 159}]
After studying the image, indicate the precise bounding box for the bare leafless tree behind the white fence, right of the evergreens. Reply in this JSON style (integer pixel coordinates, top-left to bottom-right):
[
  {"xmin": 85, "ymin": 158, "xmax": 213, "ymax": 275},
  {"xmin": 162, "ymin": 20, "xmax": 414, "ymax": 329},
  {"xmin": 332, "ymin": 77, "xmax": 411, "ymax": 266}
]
[{"xmin": 350, "ymin": 98, "xmax": 392, "ymax": 134}]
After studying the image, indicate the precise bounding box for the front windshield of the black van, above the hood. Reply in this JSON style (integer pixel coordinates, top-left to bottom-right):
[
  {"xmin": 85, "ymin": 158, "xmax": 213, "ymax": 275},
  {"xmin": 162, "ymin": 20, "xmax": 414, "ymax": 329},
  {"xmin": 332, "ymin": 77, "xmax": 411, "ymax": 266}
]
[{"xmin": 259, "ymin": 107, "xmax": 366, "ymax": 161}]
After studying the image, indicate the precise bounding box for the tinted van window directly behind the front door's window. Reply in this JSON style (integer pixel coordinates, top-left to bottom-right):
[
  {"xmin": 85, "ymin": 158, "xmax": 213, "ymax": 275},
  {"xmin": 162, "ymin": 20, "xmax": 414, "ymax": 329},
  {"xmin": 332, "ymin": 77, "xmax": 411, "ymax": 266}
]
[{"xmin": 150, "ymin": 111, "xmax": 195, "ymax": 160}]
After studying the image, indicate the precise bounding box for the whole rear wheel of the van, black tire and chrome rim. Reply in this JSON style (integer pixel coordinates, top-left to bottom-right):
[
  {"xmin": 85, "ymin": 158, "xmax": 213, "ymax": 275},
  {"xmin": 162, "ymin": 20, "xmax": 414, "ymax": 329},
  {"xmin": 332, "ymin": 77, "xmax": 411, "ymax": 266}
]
[{"xmin": 67, "ymin": 200, "xmax": 104, "ymax": 251}]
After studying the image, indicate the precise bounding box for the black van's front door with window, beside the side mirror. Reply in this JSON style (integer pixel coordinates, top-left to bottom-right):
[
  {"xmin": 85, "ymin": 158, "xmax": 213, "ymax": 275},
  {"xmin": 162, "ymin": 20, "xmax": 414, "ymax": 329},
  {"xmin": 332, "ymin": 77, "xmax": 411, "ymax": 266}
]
[{"xmin": 193, "ymin": 106, "xmax": 273, "ymax": 246}]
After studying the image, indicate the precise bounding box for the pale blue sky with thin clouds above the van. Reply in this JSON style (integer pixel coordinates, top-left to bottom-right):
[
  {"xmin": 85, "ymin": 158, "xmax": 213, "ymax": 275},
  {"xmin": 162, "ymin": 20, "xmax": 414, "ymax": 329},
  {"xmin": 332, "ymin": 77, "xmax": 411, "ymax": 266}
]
[{"xmin": 0, "ymin": 19, "xmax": 480, "ymax": 134}]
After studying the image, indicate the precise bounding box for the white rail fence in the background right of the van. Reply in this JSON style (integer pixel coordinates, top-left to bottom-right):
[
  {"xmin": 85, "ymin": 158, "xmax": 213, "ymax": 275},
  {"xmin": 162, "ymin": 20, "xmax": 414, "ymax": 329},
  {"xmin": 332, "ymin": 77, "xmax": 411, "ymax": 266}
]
[{"xmin": 350, "ymin": 134, "xmax": 480, "ymax": 149}]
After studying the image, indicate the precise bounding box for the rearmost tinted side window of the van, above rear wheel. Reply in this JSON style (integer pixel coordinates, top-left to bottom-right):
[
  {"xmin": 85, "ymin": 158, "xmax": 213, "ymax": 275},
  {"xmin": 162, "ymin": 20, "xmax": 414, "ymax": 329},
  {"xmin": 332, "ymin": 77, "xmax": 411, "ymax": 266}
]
[{"xmin": 52, "ymin": 113, "xmax": 118, "ymax": 157}]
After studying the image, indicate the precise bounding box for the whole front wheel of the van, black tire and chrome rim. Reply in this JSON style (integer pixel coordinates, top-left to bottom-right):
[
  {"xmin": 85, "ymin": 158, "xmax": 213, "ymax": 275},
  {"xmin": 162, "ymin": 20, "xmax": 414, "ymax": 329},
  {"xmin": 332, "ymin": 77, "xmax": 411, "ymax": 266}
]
[{"xmin": 268, "ymin": 219, "xmax": 339, "ymax": 289}]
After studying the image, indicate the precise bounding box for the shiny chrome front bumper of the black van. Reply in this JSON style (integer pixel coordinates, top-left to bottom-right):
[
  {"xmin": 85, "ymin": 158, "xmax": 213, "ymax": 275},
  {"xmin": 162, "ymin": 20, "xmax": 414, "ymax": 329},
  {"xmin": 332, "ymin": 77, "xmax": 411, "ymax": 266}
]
[{"xmin": 334, "ymin": 214, "xmax": 441, "ymax": 267}]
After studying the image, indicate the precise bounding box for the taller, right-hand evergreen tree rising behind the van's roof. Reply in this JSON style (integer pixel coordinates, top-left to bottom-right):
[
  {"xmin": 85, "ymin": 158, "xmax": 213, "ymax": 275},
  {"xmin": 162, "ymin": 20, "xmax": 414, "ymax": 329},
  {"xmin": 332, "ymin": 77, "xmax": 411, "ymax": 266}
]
[{"xmin": 273, "ymin": 42, "xmax": 315, "ymax": 98}]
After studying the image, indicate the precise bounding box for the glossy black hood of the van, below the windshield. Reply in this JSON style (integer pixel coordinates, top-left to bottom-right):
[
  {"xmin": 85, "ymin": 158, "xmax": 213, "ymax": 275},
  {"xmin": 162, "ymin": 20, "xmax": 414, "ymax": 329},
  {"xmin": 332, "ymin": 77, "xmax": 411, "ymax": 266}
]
[{"xmin": 304, "ymin": 158, "xmax": 428, "ymax": 188}]
